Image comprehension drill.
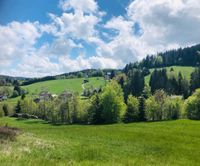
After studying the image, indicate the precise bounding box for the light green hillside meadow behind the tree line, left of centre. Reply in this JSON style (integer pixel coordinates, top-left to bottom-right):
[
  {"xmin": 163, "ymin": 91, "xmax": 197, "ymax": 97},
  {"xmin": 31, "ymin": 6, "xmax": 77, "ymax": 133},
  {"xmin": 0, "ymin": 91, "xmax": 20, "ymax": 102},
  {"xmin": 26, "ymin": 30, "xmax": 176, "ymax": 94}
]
[{"xmin": 22, "ymin": 77, "xmax": 105, "ymax": 94}]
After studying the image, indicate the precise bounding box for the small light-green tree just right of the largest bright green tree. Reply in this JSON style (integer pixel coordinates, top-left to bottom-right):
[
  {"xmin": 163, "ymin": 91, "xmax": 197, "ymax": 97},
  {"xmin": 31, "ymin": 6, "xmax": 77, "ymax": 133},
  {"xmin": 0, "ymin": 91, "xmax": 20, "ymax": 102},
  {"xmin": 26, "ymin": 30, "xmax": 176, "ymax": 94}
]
[{"xmin": 124, "ymin": 95, "xmax": 140, "ymax": 123}]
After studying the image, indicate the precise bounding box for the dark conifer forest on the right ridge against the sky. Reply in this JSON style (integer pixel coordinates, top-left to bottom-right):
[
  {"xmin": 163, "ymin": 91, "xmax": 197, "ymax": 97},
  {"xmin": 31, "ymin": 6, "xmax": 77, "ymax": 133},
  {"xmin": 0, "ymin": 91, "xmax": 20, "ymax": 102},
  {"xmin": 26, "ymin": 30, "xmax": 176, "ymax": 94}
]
[{"xmin": 125, "ymin": 44, "xmax": 200, "ymax": 70}]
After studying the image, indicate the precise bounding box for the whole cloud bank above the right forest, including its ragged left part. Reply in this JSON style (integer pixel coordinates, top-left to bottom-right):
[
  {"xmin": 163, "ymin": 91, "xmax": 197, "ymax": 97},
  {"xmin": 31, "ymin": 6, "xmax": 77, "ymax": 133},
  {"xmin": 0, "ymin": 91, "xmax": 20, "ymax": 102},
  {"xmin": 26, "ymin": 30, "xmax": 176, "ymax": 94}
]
[{"xmin": 97, "ymin": 0, "xmax": 200, "ymax": 67}]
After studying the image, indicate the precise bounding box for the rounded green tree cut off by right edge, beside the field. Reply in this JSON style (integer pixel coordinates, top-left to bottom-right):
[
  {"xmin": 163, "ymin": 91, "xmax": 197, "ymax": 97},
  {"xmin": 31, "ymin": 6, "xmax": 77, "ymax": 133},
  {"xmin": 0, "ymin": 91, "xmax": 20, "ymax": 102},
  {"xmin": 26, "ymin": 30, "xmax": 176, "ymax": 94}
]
[{"xmin": 185, "ymin": 89, "xmax": 200, "ymax": 120}]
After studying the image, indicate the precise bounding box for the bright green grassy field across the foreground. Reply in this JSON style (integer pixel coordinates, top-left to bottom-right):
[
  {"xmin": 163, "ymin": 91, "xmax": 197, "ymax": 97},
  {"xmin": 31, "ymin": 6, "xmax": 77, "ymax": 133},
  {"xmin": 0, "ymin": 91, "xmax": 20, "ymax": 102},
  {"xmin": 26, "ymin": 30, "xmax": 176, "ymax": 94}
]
[{"xmin": 0, "ymin": 118, "xmax": 200, "ymax": 166}]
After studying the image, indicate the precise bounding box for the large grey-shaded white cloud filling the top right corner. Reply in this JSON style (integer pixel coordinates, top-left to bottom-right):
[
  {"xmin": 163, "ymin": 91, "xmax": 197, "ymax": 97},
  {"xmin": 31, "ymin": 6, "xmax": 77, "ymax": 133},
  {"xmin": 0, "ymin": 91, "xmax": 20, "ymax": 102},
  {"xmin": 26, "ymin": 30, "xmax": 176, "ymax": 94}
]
[{"xmin": 127, "ymin": 0, "xmax": 200, "ymax": 51}]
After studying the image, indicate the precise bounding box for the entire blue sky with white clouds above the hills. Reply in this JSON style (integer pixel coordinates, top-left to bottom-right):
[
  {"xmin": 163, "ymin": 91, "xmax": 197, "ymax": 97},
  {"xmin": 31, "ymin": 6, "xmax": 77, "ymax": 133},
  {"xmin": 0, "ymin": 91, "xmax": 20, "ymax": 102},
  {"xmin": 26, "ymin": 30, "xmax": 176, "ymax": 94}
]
[{"xmin": 0, "ymin": 0, "xmax": 200, "ymax": 77}]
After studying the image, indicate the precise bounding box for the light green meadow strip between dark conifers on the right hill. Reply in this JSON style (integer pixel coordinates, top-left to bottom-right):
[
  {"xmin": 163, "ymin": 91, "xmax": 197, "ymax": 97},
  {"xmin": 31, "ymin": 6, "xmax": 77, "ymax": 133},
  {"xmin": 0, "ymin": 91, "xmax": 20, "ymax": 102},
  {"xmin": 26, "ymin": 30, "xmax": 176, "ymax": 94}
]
[{"xmin": 145, "ymin": 66, "xmax": 194, "ymax": 84}]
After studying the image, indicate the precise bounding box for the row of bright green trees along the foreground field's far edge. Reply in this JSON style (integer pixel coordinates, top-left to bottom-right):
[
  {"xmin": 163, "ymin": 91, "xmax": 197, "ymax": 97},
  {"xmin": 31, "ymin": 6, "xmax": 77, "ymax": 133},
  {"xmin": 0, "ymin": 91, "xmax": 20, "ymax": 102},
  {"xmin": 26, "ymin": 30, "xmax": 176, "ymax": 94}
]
[{"xmin": 0, "ymin": 80, "xmax": 200, "ymax": 124}]
